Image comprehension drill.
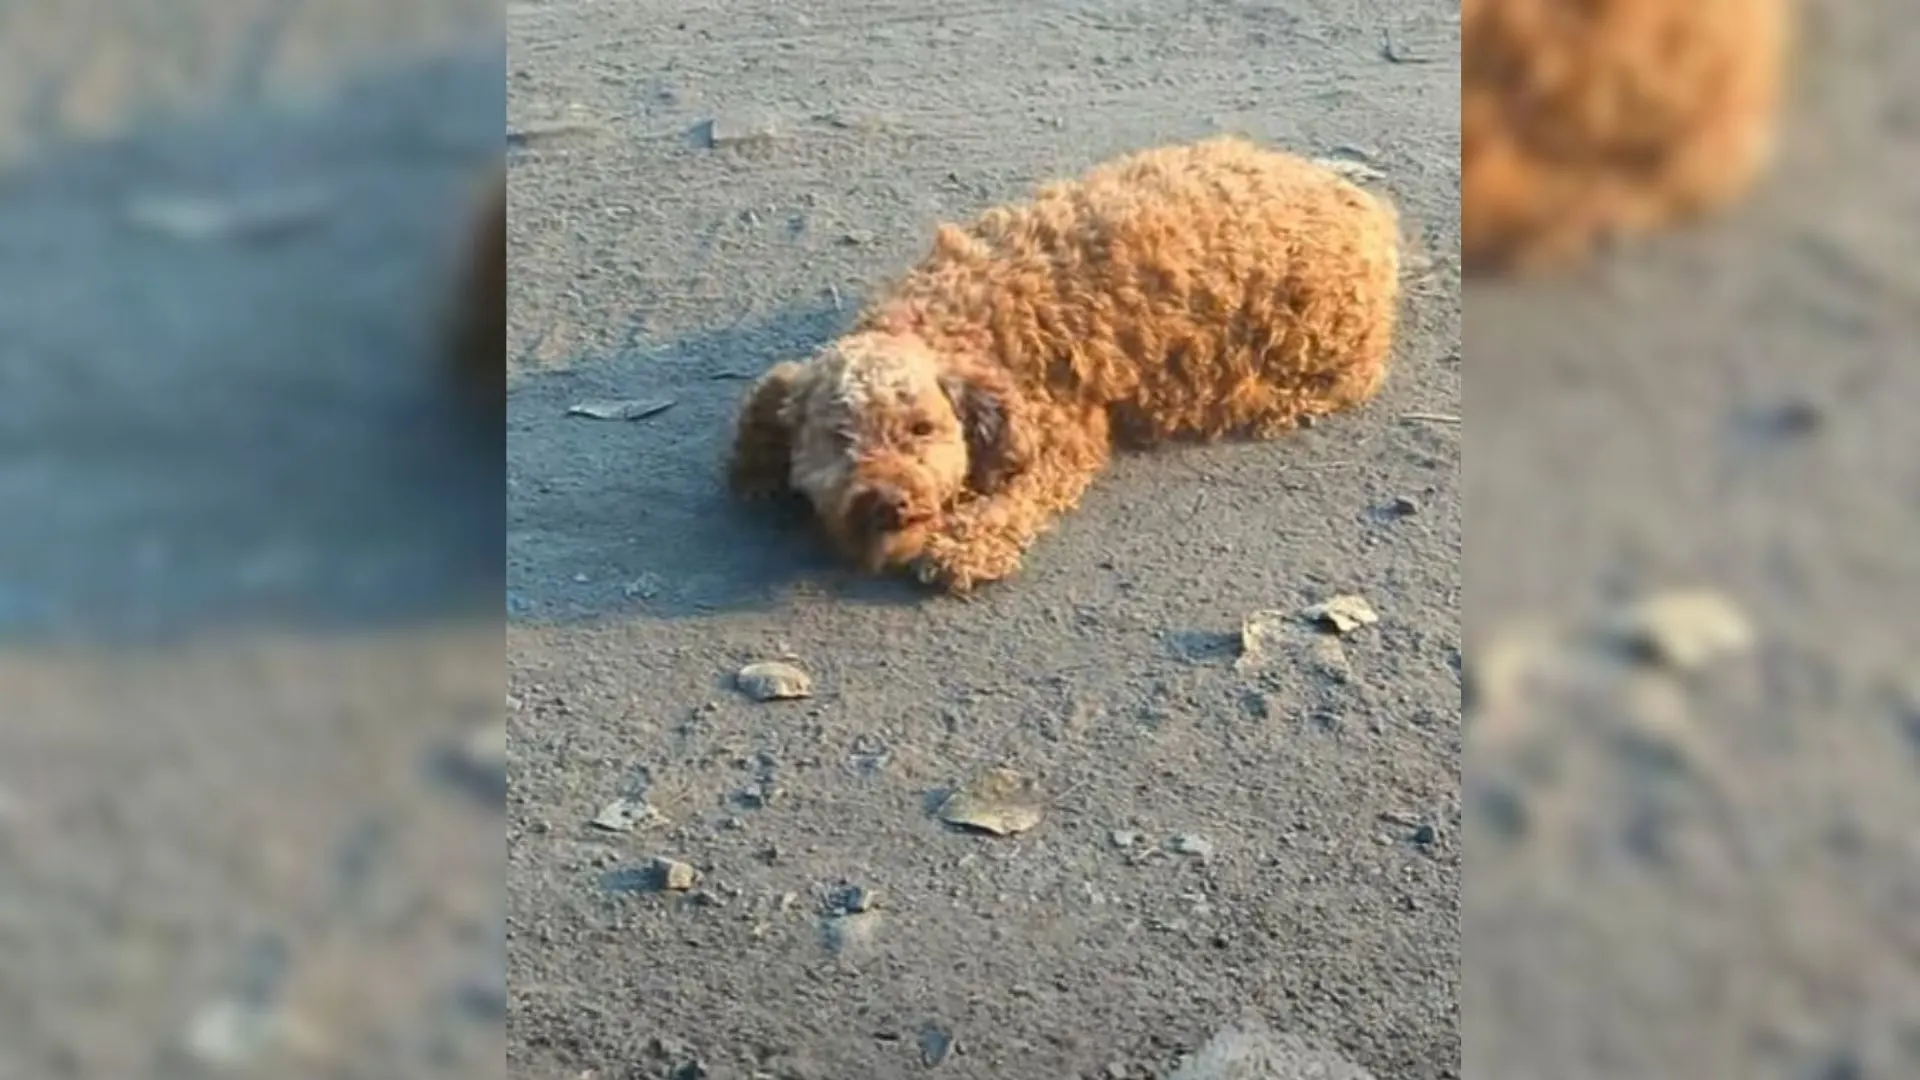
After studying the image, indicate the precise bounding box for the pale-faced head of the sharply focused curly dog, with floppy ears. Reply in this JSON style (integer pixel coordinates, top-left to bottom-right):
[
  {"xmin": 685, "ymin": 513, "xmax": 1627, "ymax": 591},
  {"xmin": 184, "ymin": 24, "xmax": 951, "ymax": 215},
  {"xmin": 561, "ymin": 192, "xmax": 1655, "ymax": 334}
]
[{"xmin": 732, "ymin": 334, "xmax": 1027, "ymax": 569}]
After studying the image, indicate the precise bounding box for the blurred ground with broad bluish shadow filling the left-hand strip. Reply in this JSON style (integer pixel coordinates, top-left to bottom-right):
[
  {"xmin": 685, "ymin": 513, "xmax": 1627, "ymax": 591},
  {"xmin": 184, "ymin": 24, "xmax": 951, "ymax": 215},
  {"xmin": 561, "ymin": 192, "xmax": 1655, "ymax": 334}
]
[{"xmin": 0, "ymin": 0, "xmax": 505, "ymax": 1080}]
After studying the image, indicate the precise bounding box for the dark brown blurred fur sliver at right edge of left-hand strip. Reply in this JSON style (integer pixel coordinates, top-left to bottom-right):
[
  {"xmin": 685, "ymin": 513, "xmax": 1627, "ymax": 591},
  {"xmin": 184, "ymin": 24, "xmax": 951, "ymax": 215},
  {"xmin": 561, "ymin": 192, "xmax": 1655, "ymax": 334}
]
[{"xmin": 445, "ymin": 167, "xmax": 507, "ymax": 407}]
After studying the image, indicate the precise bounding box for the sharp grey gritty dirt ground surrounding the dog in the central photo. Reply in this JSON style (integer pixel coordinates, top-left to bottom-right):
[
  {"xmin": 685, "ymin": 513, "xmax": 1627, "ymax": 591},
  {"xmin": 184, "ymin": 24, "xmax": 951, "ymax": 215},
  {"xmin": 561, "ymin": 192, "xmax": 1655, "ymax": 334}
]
[{"xmin": 507, "ymin": 0, "xmax": 1461, "ymax": 1080}]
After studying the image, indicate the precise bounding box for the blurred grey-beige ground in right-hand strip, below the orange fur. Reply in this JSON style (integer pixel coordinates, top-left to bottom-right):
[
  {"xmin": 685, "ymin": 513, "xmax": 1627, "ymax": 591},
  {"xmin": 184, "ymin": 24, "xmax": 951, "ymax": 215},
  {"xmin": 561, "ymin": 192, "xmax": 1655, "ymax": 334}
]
[{"xmin": 1463, "ymin": 0, "xmax": 1920, "ymax": 1080}]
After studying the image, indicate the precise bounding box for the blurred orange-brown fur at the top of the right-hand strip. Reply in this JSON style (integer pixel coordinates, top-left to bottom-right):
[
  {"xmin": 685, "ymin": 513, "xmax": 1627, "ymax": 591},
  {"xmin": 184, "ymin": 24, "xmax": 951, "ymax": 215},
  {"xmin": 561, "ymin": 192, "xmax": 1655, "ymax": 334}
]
[{"xmin": 1459, "ymin": 0, "xmax": 1791, "ymax": 273}]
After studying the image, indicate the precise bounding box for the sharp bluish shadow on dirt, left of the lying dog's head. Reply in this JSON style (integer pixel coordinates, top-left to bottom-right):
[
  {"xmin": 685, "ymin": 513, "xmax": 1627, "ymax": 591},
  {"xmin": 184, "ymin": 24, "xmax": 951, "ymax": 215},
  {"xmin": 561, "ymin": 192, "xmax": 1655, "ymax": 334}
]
[{"xmin": 507, "ymin": 306, "xmax": 925, "ymax": 623}]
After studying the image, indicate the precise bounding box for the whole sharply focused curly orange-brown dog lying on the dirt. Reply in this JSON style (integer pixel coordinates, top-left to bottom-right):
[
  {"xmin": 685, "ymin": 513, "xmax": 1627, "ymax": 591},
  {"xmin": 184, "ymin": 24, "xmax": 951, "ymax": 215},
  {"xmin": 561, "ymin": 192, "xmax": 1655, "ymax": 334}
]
[{"xmin": 732, "ymin": 138, "xmax": 1400, "ymax": 592}]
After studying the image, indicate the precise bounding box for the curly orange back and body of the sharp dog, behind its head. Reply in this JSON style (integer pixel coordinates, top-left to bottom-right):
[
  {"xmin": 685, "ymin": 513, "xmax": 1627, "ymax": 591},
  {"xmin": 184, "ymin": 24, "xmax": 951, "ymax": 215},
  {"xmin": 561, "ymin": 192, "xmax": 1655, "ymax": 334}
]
[{"xmin": 868, "ymin": 136, "xmax": 1400, "ymax": 440}]
